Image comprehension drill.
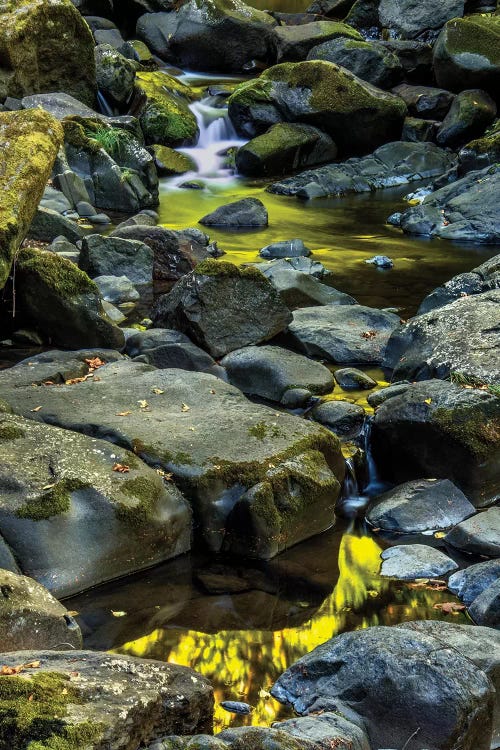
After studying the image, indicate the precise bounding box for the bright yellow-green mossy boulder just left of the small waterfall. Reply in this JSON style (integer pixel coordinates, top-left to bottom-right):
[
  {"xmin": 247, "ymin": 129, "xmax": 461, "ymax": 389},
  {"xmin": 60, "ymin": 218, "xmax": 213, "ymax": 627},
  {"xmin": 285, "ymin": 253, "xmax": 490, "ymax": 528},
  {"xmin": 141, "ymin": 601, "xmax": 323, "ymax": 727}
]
[{"xmin": 137, "ymin": 71, "xmax": 198, "ymax": 146}]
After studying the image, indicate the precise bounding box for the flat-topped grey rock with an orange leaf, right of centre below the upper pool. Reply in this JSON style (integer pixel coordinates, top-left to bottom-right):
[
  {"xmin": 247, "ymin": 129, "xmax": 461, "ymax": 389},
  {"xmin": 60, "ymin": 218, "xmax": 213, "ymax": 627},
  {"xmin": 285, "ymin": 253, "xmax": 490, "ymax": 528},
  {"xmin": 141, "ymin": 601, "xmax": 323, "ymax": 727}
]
[{"xmin": 287, "ymin": 305, "xmax": 399, "ymax": 364}]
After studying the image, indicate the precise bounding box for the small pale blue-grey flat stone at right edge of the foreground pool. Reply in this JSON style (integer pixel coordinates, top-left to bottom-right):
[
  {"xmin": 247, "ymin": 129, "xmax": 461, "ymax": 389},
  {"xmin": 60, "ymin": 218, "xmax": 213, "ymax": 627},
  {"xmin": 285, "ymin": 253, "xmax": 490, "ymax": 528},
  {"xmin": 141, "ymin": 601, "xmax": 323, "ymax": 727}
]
[{"xmin": 380, "ymin": 544, "xmax": 458, "ymax": 581}]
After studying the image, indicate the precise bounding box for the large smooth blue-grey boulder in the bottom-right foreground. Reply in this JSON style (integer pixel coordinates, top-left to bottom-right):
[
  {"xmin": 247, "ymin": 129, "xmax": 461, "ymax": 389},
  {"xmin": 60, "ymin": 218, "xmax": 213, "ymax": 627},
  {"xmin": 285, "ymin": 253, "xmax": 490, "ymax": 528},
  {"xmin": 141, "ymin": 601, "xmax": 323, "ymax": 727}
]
[{"xmin": 271, "ymin": 627, "xmax": 494, "ymax": 750}]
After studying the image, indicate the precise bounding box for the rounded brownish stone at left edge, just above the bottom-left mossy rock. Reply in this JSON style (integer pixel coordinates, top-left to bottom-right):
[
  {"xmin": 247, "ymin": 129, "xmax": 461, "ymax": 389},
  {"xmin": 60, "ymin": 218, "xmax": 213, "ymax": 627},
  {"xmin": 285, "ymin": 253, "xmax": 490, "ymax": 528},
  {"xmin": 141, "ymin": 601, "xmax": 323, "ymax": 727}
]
[{"xmin": 0, "ymin": 568, "xmax": 82, "ymax": 651}]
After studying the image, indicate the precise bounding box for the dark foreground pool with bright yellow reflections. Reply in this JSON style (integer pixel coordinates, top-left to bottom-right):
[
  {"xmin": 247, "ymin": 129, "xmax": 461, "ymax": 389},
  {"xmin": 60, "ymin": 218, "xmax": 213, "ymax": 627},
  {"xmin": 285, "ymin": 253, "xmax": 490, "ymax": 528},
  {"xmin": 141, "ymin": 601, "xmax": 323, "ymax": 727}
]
[{"xmin": 67, "ymin": 523, "xmax": 465, "ymax": 731}]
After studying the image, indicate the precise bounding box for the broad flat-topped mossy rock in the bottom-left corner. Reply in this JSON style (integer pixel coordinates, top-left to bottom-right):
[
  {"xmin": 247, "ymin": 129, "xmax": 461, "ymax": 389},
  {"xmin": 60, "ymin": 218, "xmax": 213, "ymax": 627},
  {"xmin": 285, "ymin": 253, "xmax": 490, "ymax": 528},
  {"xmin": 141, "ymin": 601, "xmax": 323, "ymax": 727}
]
[{"xmin": 0, "ymin": 651, "xmax": 213, "ymax": 750}]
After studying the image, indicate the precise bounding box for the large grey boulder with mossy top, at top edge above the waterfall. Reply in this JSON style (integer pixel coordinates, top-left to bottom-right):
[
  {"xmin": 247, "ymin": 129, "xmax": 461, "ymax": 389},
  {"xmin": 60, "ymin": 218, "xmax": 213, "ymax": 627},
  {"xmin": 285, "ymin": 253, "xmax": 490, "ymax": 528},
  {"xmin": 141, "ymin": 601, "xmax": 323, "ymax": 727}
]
[{"xmin": 137, "ymin": 0, "xmax": 277, "ymax": 72}]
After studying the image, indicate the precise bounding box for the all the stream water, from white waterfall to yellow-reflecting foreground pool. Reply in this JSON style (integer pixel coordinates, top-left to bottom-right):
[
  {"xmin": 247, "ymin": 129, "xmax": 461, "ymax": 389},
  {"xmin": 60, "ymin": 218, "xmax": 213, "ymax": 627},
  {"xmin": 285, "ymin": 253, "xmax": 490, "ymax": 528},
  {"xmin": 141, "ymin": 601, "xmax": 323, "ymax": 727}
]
[{"xmin": 63, "ymin": 69, "xmax": 500, "ymax": 731}]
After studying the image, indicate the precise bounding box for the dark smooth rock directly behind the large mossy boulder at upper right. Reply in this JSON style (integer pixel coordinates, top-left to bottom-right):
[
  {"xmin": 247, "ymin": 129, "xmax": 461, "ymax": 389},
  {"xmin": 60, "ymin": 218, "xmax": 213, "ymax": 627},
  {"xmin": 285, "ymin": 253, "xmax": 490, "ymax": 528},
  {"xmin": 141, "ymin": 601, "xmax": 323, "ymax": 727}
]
[{"xmin": 307, "ymin": 38, "xmax": 403, "ymax": 89}]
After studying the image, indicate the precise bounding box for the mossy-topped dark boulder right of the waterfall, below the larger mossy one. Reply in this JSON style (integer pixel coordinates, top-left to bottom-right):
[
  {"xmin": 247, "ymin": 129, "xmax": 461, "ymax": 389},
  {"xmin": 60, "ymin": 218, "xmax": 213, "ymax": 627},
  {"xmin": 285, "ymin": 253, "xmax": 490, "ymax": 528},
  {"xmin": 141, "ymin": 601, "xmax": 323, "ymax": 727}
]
[{"xmin": 236, "ymin": 122, "xmax": 337, "ymax": 177}]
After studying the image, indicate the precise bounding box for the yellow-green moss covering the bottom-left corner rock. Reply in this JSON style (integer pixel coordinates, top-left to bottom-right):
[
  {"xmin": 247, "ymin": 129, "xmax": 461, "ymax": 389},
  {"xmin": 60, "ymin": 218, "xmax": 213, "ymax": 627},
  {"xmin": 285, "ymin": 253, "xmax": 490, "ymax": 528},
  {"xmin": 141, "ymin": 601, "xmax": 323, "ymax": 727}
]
[{"xmin": 0, "ymin": 672, "xmax": 104, "ymax": 750}]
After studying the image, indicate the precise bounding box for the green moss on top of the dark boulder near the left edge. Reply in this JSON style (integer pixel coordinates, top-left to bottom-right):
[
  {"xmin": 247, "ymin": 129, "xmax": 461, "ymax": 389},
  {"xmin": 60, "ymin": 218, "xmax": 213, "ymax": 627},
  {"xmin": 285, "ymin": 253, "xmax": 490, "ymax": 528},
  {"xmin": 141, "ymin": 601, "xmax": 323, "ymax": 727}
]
[{"xmin": 18, "ymin": 248, "xmax": 99, "ymax": 298}]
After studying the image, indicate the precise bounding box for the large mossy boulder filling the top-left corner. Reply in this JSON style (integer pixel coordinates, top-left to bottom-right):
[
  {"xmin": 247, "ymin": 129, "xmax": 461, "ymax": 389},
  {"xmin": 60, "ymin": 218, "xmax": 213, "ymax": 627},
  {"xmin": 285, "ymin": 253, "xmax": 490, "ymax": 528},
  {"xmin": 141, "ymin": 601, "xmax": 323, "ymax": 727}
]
[{"xmin": 0, "ymin": 0, "xmax": 97, "ymax": 106}]
